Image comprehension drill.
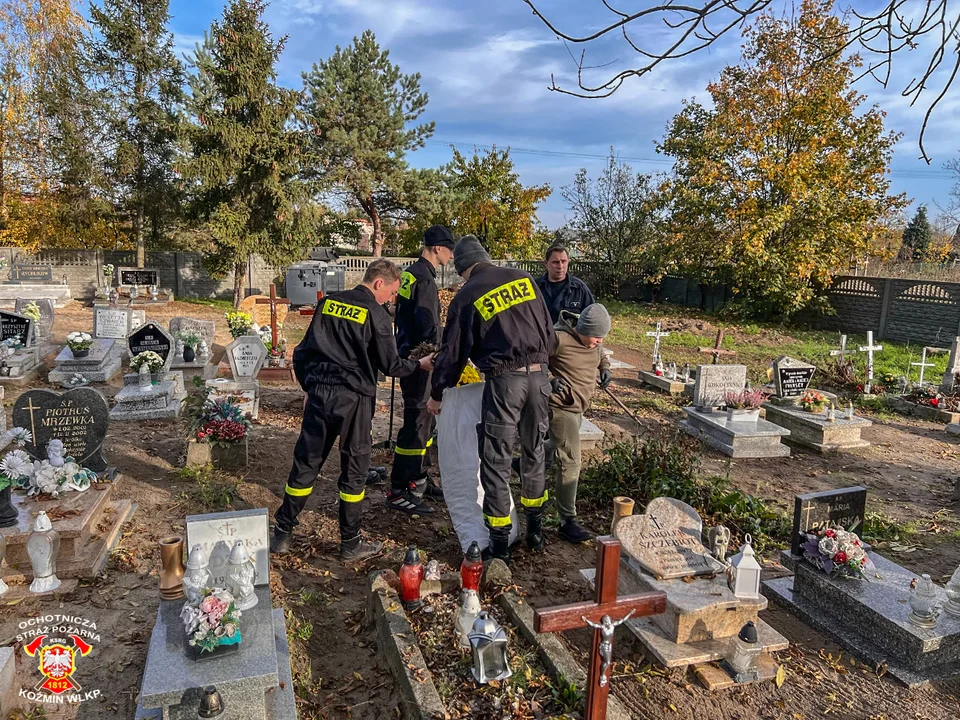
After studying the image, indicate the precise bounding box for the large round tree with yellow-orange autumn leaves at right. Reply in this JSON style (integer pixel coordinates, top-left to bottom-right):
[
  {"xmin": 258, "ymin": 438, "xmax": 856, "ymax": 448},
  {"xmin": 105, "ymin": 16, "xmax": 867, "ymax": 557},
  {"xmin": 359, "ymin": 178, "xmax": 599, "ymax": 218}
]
[{"xmin": 658, "ymin": 0, "xmax": 904, "ymax": 316}]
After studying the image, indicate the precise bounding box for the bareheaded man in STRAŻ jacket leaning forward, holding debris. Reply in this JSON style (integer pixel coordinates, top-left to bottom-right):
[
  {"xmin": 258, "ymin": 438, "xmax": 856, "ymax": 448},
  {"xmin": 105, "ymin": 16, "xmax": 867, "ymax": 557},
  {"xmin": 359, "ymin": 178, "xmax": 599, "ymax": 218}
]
[{"xmin": 270, "ymin": 259, "xmax": 433, "ymax": 561}]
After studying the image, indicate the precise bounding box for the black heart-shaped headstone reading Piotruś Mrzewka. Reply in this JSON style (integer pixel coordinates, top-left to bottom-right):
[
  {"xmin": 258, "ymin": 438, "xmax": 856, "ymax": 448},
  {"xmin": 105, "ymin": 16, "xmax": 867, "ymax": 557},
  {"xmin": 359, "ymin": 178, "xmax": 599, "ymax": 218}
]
[{"xmin": 13, "ymin": 388, "xmax": 110, "ymax": 472}]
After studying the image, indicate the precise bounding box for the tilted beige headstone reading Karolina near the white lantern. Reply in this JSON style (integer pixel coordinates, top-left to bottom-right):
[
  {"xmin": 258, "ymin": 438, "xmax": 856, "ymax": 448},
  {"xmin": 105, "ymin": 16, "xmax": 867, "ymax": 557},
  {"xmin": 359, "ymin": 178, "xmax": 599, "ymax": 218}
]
[{"xmin": 615, "ymin": 498, "xmax": 723, "ymax": 579}]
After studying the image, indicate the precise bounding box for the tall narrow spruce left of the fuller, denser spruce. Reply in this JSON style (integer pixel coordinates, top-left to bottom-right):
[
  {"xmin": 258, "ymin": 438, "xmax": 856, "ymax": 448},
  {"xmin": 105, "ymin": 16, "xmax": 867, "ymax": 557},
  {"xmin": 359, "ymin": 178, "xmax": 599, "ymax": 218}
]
[{"xmin": 90, "ymin": 0, "xmax": 184, "ymax": 267}]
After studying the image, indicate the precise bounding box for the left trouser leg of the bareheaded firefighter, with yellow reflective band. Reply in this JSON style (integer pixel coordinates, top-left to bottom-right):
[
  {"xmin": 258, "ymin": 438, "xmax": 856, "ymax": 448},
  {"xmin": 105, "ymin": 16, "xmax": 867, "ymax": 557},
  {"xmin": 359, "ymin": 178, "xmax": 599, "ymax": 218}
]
[{"xmin": 274, "ymin": 386, "xmax": 340, "ymax": 532}]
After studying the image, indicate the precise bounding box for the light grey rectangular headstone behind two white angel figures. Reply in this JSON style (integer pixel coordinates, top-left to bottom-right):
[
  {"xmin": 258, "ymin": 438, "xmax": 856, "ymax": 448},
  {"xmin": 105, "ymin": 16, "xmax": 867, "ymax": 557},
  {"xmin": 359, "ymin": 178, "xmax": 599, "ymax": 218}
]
[{"xmin": 186, "ymin": 508, "xmax": 270, "ymax": 587}]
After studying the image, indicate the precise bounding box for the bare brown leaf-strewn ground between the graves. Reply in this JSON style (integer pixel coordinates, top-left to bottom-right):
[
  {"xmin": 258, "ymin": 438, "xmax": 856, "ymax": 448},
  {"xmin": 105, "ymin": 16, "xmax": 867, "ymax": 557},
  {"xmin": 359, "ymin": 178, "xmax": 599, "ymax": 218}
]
[{"xmin": 0, "ymin": 302, "xmax": 960, "ymax": 720}]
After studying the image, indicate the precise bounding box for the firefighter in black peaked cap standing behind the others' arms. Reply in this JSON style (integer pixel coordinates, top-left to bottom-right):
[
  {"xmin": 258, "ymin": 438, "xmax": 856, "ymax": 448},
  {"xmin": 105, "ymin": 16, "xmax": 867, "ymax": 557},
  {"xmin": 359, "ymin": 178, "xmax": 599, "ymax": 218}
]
[{"xmin": 386, "ymin": 225, "xmax": 454, "ymax": 515}]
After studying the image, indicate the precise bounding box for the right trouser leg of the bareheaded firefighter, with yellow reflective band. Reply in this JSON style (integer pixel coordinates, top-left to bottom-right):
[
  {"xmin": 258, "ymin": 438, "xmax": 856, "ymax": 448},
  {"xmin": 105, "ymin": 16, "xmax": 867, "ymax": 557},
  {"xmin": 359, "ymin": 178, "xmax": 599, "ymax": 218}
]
[{"xmin": 337, "ymin": 395, "xmax": 374, "ymax": 541}]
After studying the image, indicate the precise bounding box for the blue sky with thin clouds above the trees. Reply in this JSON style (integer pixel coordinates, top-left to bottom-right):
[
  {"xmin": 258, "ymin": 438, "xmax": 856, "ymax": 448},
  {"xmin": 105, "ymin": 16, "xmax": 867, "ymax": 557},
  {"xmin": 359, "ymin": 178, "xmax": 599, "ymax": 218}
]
[{"xmin": 171, "ymin": 0, "xmax": 960, "ymax": 227}]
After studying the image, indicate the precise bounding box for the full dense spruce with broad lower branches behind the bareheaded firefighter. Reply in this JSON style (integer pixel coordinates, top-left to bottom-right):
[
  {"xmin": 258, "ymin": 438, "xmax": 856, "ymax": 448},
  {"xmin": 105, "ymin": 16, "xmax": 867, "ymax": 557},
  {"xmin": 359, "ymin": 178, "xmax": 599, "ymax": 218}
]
[{"xmin": 181, "ymin": 0, "xmax": 315, "ymax": 305}]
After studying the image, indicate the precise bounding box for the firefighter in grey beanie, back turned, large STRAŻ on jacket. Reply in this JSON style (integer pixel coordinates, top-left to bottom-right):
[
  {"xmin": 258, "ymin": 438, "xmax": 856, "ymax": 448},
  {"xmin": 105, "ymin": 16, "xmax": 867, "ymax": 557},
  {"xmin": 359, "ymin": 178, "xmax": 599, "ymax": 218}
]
[{"xmin": 427, "ymin": 235, "xmax": 554, "ymax": 561}]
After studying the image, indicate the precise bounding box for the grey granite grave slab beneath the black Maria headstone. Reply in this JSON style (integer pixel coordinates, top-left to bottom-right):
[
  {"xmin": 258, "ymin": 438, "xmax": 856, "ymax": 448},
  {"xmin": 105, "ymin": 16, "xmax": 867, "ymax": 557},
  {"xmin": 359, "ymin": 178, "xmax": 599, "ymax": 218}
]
[{"xmin": 763, "ymin": 553, "xmax": 960, "ymax": 687}]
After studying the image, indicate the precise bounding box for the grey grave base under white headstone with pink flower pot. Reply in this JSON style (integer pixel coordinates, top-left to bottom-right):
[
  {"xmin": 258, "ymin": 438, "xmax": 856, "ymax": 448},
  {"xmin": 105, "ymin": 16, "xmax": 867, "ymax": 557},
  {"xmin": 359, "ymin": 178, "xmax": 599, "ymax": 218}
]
[{"xmin": 680, "ymin": 408, "xmax": 790, "ymax": 458}]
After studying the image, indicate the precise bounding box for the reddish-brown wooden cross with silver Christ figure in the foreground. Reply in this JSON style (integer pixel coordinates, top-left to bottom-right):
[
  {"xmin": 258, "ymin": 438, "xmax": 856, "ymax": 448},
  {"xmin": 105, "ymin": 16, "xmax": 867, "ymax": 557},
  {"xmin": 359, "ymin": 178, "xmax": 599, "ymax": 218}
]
[{"xmin": 533, "ymin": 537, "xmax": 667, "ymax": 720}]
